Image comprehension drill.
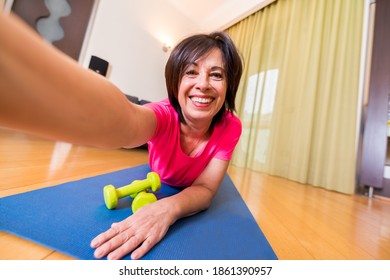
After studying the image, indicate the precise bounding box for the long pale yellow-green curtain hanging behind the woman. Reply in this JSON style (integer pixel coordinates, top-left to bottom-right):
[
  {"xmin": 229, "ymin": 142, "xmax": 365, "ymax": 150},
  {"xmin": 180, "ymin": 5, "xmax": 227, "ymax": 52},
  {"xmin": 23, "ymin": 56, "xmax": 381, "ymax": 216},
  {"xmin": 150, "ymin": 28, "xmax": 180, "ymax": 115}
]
[{"xmin": 227, "ymin": 0, "xmax": 364, "ymax": 193}]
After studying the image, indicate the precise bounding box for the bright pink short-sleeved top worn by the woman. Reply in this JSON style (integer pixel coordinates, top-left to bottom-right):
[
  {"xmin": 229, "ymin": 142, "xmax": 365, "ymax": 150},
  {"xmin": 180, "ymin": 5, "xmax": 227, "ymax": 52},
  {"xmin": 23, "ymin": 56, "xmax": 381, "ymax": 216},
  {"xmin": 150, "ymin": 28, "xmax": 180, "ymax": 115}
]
[{"xmin": 145, "ymin": 99, "xmax": 242, "ymax": 187}]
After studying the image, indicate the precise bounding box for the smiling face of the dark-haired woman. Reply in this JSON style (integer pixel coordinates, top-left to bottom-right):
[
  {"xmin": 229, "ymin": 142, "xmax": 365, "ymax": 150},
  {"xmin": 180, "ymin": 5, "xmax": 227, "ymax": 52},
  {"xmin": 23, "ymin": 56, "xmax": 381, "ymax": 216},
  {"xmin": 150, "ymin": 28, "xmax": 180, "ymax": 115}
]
[{"xmin": 178, "ymin": 49, "xmax": 227, "ymax": 124}]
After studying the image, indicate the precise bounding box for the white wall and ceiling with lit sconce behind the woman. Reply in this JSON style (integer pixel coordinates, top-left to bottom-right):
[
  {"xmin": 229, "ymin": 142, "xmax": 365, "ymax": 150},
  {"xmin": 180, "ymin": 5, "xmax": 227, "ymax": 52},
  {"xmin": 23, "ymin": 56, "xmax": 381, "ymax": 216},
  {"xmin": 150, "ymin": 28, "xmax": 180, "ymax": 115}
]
[{"xmin": 80, "ymin": 0, "xmax": 264, "ymax": 101}]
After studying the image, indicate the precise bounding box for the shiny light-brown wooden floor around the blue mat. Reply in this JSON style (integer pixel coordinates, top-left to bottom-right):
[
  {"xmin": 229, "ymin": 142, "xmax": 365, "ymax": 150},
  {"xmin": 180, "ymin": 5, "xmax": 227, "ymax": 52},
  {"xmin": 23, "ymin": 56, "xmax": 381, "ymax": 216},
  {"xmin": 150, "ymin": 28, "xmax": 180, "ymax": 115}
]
[{"xmin": 0, "ymin": 129, "xmax": 390, "ymax": 260}]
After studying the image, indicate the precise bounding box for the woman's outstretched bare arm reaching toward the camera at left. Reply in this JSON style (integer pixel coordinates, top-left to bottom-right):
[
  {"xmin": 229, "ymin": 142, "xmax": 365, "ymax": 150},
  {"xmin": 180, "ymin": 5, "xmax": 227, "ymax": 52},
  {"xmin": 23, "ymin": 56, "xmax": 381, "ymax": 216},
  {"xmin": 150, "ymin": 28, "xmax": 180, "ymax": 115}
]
[{"xmin": 0, "ymin": 12, "xmax": 156, "ymax": 148}]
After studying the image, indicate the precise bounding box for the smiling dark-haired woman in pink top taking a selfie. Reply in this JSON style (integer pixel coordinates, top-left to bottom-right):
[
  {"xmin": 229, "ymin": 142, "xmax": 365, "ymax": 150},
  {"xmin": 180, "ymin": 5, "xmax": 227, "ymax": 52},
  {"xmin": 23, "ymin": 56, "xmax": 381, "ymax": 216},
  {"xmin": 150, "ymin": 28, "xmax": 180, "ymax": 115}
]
[{"xmin": 0, "ymin": 12, "xmax": 242, "ymax": 259}]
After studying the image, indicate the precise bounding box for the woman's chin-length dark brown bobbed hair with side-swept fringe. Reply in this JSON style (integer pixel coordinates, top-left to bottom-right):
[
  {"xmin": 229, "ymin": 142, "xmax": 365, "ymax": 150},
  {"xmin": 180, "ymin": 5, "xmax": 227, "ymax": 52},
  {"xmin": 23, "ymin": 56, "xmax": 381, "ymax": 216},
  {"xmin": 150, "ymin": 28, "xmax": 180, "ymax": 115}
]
[{"xmin": 165, "ymin": 32, "xmax": 242, "ymax": 125}]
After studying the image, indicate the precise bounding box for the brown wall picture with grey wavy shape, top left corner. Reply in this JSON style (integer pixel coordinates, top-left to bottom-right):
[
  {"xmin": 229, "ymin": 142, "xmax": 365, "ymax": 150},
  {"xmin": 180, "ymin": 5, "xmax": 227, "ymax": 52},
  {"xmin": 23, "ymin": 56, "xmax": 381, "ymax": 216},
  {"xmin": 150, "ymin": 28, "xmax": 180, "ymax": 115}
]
[{"xmin": 0, "ymin": 0, "xmax": 99, "ymax": 62}]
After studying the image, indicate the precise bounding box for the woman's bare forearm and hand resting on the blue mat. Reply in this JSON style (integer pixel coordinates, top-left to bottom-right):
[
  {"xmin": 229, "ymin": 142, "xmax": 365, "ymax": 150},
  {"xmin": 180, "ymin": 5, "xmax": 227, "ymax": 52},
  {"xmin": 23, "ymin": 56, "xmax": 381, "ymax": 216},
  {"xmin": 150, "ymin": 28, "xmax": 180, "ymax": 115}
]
[{"xmin": 91, "ymin": 159, "xmax": 229, "ymax": 259}]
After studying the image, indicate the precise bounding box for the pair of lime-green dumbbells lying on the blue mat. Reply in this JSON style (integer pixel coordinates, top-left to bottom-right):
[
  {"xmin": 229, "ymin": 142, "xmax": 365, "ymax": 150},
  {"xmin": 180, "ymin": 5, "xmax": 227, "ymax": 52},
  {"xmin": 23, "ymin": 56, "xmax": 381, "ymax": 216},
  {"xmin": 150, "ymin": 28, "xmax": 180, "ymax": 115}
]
[{"xmin": 103, "ymin": 172, "xmax": 161, "ymax": 213}]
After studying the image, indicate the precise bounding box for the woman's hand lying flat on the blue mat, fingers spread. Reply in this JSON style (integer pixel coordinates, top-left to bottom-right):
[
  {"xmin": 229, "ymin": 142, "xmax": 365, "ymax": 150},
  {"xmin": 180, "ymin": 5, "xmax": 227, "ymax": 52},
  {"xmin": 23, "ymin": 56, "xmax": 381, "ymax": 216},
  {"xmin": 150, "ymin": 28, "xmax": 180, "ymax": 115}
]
[{"xmin": 91, "ymin": 200, "xmax": 174, "ymax": 259}]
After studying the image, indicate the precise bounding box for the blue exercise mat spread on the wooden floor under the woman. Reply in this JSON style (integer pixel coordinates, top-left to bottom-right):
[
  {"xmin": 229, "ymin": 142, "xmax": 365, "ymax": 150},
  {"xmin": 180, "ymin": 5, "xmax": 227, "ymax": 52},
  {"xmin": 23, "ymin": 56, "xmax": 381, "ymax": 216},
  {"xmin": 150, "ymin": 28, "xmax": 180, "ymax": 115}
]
[{"xmin": 0, "ymin": 165, "xmax": 277, "ymax": 260}]
